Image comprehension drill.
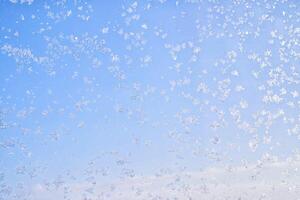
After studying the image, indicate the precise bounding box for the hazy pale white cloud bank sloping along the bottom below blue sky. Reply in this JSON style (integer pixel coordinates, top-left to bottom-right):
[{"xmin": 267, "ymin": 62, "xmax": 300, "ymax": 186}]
[{"xmin": 32, "ymin": 161, "xmax": 300, "ymax": 200}]
